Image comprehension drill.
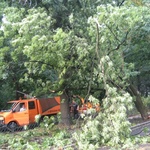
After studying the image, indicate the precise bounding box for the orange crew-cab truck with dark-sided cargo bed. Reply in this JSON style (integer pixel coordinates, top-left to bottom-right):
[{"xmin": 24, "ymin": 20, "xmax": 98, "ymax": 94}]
[{"xmin": 0, "ymin": 97, "xmax": 60, "ymax": 129}]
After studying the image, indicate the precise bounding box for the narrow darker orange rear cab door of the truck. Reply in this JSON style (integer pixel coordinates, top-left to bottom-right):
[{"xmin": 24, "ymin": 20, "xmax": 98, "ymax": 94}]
[{"xmin": 28, "ymin": 100, "xmax": 38, "ymax": 123}]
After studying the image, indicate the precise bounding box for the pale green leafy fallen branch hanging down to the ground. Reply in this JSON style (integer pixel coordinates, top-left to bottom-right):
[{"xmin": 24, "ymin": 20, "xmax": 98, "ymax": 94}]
[{"xmin": 74, "ymin": 54, "xmax": 132, "ymax": 149}]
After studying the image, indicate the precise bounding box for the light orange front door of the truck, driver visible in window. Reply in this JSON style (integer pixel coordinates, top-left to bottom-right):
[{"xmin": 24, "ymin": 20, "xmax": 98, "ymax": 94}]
[{"xmin": 13, "ymin": 102, "xmax": 29, "ymax": 126}]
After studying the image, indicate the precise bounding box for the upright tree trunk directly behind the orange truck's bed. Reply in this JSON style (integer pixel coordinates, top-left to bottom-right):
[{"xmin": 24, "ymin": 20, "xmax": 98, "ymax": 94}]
[{"xmin": 61, "ymin": 93, "xmax": 71, "ymax": 126}]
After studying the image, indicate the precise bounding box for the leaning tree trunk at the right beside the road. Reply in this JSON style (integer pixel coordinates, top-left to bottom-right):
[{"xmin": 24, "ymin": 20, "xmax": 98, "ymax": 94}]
[{"xmin": 129, "ymin": 84, "xmax": 148, "ymax": 120}]
